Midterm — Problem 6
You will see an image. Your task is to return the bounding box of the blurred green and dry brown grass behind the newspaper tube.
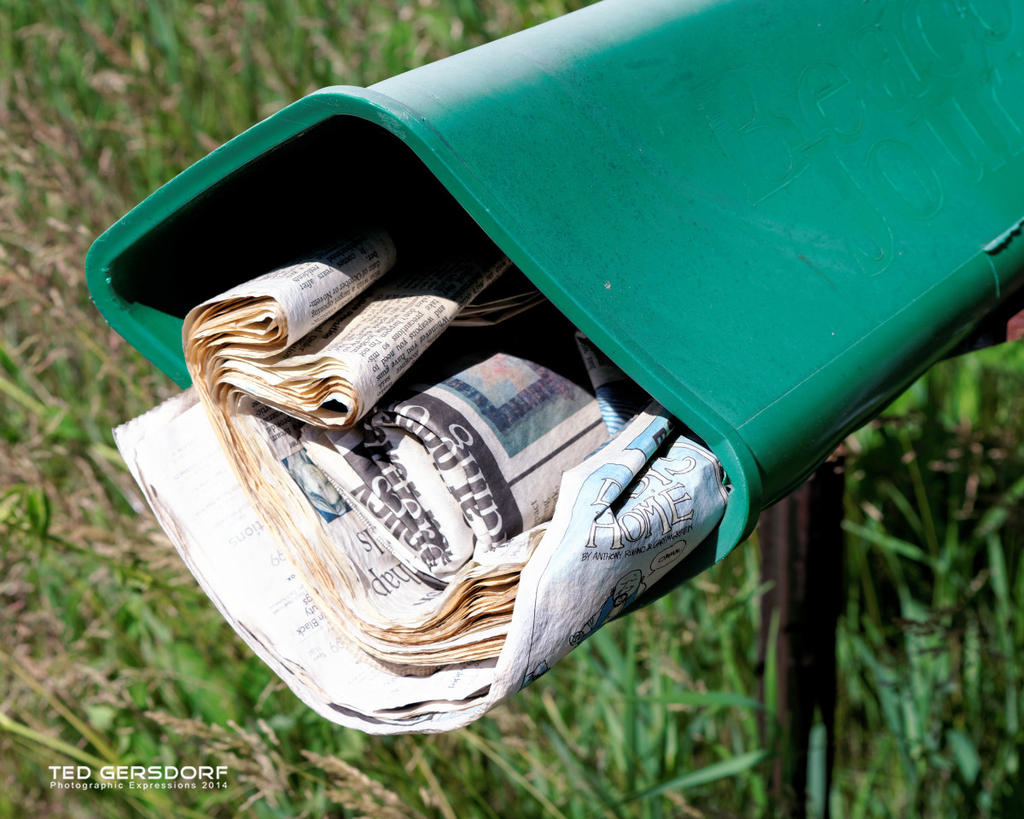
[6,0,1024,817]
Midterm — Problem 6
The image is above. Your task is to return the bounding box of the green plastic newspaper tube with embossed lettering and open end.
[87,0,1024,574]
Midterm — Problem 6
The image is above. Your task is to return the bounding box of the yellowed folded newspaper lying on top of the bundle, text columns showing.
[182,225,510,427]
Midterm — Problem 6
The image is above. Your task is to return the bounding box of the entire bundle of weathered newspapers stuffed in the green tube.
[115,230,727,733]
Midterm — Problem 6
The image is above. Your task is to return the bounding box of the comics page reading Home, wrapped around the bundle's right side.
[490,402,728,702]
